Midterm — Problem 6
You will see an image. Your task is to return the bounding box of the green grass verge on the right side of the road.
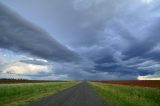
[90,82,160,106]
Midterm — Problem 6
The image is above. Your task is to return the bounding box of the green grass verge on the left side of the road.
[0,82,77,106]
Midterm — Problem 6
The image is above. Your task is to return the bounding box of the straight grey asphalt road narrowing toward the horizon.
[28,82,103,106]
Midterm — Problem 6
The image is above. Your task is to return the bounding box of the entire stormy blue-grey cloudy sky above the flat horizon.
[0,0,160,80]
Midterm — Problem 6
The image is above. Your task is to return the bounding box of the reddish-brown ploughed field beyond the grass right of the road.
[95,80,160,88]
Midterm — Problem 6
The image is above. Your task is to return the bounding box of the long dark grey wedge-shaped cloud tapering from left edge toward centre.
[0,4,79,61]
